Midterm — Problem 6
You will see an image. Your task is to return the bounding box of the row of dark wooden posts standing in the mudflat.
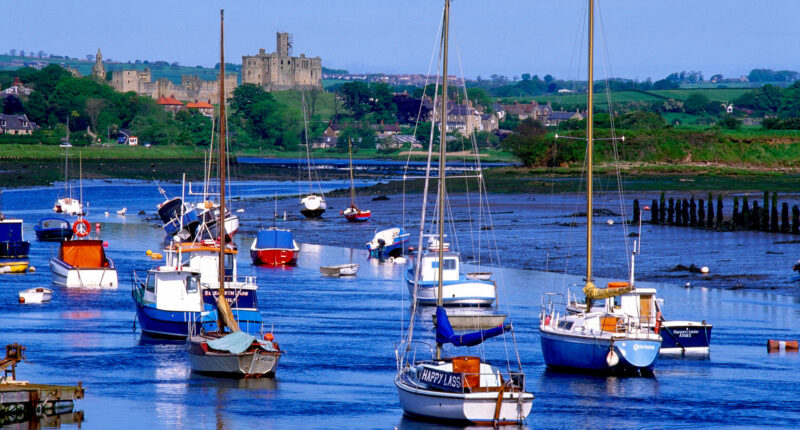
[633,191,800,234]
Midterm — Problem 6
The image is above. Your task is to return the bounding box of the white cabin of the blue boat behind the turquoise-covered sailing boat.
[143,266,203,312]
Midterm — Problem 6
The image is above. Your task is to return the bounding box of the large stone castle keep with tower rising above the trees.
[242,33,322,91]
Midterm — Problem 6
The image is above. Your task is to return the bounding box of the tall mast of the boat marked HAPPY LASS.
[436,0,450,360]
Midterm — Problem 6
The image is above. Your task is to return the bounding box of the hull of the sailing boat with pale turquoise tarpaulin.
[186,336,280,378]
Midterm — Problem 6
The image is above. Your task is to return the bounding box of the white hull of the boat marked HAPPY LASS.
[395,376,533,425]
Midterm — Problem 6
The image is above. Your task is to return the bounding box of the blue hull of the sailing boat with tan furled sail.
[539,329,661,374]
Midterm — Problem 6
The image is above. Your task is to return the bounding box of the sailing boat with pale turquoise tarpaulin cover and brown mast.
[186,10,282,378]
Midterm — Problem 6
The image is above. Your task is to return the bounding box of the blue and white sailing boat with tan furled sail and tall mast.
[539,0,661,374]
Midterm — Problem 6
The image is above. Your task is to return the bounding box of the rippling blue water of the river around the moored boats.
[0,181,800,429]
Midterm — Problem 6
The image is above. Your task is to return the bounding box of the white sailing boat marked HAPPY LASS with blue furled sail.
[394,0,533,425]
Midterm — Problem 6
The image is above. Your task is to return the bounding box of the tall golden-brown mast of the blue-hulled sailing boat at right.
[585,0,594,286]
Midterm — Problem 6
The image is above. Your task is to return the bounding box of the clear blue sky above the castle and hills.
[6,0,800,80]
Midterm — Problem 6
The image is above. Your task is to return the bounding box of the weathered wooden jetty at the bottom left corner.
[0,343,84,425]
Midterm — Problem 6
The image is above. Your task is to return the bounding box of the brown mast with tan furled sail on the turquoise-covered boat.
[217,9,240,334]
